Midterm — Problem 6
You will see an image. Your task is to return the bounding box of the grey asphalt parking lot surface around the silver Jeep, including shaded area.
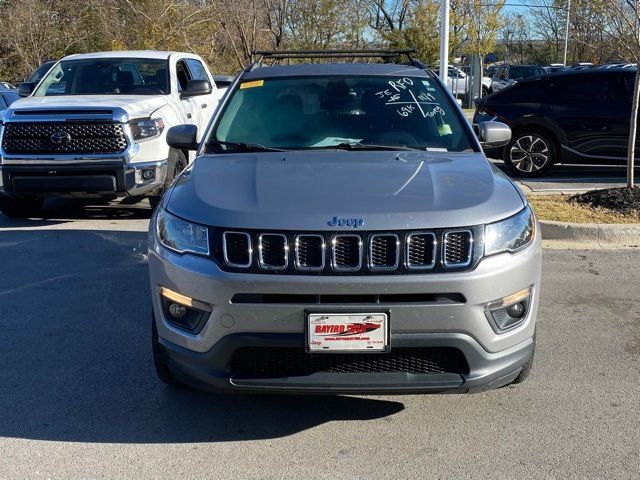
[0,193,640,479]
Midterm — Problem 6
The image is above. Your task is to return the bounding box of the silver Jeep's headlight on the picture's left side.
[156,209,209,256]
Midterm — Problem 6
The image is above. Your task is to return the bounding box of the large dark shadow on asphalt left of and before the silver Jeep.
[0,229,404,443]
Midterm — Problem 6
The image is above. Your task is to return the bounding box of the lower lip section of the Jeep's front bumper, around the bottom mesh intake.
[160,333,534,394]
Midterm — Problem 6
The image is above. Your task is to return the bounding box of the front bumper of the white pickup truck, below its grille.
[0,160,167,197]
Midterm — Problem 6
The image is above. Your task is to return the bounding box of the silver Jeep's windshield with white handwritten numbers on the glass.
[206,75,473,152]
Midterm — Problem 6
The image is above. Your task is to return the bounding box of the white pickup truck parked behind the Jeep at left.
[0,51,220,218]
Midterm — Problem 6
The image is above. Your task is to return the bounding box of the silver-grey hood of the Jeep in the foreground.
[167,150,524,231]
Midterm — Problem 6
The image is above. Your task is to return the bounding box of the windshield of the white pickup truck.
[34,58,169,97]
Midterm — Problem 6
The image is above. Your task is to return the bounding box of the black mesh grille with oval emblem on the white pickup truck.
[2,122,127,155]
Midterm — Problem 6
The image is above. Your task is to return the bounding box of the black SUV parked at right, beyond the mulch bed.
[473,69,635,177]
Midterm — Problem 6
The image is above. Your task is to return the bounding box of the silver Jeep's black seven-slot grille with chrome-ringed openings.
[216,227,482,275]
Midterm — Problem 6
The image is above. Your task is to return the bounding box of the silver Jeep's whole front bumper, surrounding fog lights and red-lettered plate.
[149,229,541,393]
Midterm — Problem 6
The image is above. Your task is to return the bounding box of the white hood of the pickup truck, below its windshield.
[11,95,167,118]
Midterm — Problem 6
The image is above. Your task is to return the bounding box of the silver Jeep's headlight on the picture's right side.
[484,206,536,255]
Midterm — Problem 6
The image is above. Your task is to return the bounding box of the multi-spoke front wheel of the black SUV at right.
[503,129,557,178]
